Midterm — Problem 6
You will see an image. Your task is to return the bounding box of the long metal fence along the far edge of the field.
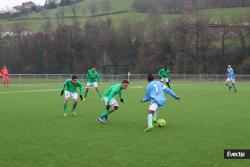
[6,74,250,83]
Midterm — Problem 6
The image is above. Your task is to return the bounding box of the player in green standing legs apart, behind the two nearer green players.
[83,66,102,101]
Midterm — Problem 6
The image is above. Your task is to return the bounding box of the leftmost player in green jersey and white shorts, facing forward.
[61,75,83,117]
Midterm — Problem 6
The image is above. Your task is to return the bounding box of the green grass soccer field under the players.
[0,82,250,167]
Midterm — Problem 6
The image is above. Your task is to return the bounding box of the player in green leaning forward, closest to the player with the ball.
[98,80,129,123]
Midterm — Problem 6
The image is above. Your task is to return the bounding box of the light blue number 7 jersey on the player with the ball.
[142,81,178,106]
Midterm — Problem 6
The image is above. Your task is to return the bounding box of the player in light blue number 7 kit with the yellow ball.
[141,74,180,132]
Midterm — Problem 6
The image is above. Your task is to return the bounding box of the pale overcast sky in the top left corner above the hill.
[0,0,46,10]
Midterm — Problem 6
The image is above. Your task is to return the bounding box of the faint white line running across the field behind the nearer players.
[0,84,193,94]
